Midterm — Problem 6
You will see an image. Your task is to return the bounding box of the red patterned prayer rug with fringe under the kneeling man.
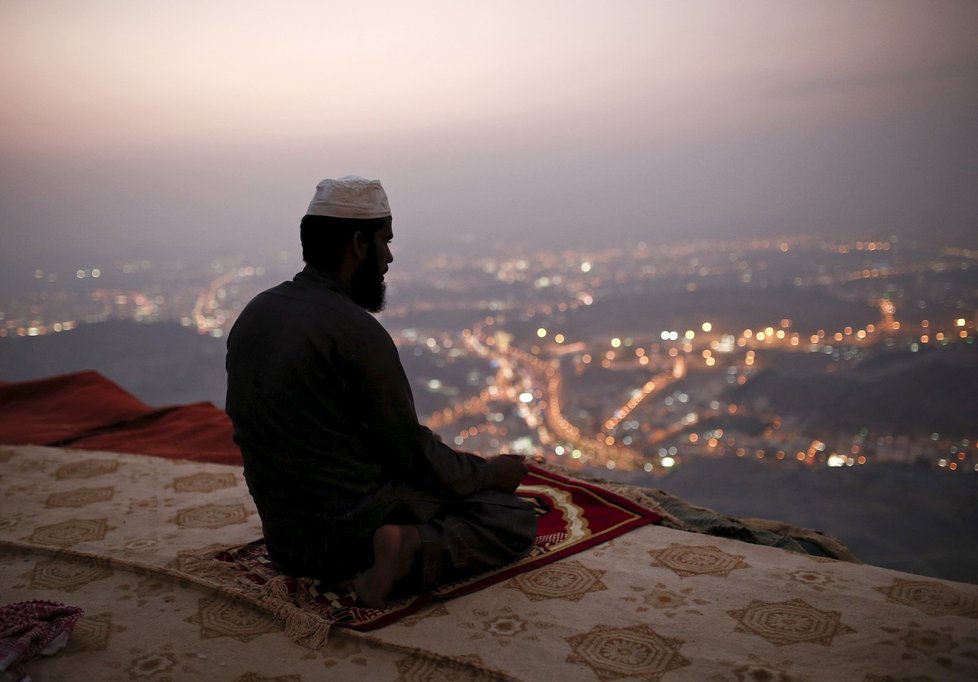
[195,465,661,628]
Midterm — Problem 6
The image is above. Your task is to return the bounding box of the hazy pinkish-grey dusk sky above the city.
[0,0,978,256]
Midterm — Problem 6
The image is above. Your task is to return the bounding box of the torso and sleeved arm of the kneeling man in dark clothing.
[226,267,508,571]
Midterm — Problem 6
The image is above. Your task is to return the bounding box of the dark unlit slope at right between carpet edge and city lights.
[616,457,978,582]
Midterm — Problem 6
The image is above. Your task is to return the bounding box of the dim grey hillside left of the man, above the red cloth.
[0,320,226,406]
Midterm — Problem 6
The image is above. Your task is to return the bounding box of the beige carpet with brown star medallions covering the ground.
[0,446,978,682]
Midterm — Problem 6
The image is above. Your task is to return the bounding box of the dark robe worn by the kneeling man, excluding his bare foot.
[226,266,536,587]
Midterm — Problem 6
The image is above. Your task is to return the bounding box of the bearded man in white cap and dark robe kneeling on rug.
[227,176,536,607]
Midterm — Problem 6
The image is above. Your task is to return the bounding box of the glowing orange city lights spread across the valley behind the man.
[0,241,978,476]
